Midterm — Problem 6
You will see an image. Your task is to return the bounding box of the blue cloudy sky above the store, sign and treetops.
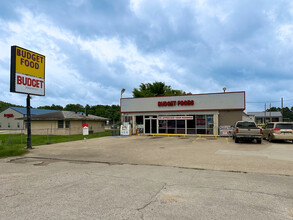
[0,0,293,111]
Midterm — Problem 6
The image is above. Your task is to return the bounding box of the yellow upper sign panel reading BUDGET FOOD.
[15,46,45,79]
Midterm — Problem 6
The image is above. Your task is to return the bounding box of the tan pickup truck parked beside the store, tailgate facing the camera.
[233,121,262,144]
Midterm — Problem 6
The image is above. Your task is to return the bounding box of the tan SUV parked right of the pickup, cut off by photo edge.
[263,122,293,142]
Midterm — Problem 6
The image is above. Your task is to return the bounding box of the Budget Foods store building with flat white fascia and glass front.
[120,91,245,135]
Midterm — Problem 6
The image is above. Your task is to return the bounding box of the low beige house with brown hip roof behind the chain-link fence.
[25,111,108,135]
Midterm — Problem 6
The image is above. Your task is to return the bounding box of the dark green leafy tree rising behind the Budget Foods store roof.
[132,82,191,98]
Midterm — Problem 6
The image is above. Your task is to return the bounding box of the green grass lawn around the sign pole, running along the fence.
[0,130,116,158]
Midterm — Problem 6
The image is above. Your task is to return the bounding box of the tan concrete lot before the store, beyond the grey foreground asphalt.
[25,136,293,176]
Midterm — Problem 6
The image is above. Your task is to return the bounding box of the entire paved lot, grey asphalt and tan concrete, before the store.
[0,136,293,219]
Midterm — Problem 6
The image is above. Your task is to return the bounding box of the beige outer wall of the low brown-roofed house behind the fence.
[25,120,105,135]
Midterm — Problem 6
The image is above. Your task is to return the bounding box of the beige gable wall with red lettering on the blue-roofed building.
[0,108,23,129]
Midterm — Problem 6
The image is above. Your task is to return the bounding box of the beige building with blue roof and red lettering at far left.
[0,107,57,130]
